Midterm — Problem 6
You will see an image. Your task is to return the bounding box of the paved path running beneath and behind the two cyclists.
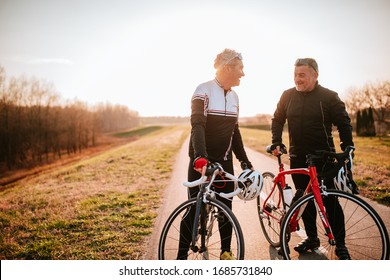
[143,138,390,260]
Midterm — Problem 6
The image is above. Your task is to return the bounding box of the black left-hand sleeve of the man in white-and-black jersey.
[191,99,207,158]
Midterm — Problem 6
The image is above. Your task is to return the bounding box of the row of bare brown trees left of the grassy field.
[0,66,139,170]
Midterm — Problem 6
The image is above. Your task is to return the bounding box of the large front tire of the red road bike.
[280,190,389,260]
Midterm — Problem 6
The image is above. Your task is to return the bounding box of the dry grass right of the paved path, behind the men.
[241,128,390,205]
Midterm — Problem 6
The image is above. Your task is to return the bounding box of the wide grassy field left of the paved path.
[0,127,188,260]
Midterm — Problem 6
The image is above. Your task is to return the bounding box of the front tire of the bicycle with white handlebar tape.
[158,198,245,260]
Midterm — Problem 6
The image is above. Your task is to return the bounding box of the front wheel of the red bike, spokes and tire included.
[280,190,389,260]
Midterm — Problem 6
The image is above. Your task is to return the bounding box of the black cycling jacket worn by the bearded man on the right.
[272,83,353,158]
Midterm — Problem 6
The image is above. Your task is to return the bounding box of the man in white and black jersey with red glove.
[178,49,253,260]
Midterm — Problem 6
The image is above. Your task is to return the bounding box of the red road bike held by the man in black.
[257,147,389,260]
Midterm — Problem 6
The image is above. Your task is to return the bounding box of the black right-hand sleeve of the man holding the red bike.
[331,93,354,151]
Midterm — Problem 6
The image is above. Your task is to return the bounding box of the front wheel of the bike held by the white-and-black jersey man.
[158,198,244,260]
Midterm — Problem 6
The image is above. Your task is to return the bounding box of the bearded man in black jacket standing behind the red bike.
[272,58,353,259]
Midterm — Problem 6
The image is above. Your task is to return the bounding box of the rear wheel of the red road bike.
[257,172,285,247]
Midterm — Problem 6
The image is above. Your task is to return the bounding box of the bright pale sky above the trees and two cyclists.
[0,0,390,117]
